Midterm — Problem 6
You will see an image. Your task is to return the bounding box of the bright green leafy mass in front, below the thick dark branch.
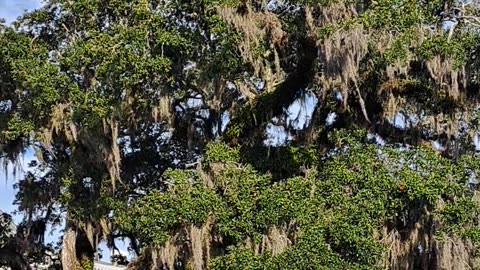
[115,139,480,269]
